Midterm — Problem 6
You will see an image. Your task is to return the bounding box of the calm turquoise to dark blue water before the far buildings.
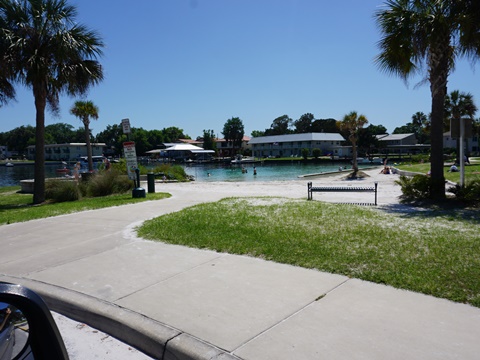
[0,161,368,186]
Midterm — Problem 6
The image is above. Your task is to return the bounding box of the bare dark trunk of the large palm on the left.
[33,85,47,204]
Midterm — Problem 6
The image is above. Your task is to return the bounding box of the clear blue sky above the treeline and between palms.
[0,0,480,138]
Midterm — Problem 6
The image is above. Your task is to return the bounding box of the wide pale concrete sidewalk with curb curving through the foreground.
[0,185,480,360]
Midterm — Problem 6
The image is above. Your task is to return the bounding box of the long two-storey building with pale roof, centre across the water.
[249,133,344,157]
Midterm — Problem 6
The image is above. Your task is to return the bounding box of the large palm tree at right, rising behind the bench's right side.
[375,0,480,199]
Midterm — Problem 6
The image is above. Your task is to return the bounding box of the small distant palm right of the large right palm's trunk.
[445,90,477,163]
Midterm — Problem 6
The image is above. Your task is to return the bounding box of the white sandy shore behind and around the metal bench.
[156,168,401,206]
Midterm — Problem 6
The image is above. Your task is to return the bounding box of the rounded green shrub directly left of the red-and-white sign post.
[86,169,133,197]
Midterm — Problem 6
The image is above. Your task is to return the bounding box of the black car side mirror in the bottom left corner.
[0,282,68,360]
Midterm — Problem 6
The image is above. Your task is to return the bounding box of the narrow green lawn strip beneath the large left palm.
[0,186,171,225]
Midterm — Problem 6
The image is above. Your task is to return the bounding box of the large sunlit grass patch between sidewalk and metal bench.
[138,198,480,307]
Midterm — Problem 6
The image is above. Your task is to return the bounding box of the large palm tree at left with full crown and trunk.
[0,0,103,204]
